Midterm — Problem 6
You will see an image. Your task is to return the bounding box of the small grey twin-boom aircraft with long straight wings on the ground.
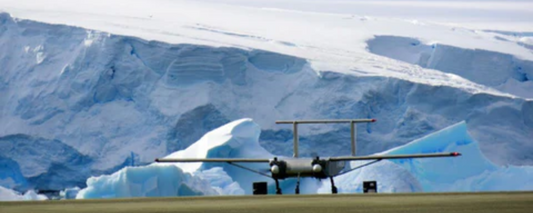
[155,119,461,194]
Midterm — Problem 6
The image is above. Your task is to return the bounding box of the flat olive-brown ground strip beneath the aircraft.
[0,192,533,213]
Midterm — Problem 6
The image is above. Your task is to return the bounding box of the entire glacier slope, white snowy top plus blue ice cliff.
[0,0,533,195]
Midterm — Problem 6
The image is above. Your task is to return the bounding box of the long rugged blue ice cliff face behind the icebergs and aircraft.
[0,13,533,195]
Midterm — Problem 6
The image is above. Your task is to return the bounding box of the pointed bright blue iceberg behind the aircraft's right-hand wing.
[326,122,533,193]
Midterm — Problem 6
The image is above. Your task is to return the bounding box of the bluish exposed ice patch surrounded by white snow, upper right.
[368,36,533,98]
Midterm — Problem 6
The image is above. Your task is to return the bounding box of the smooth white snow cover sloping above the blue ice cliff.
[2,0,533,86]
